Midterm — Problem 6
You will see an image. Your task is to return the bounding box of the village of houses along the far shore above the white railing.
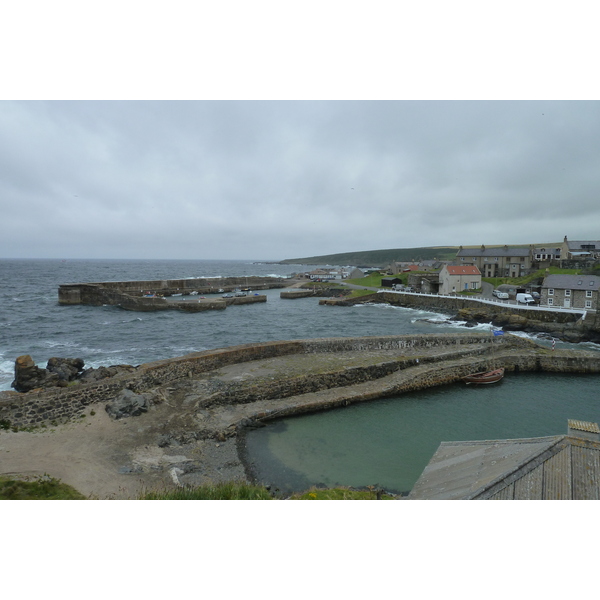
[304,236,600,311]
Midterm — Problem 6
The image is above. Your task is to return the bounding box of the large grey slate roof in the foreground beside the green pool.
[408,426,600,500]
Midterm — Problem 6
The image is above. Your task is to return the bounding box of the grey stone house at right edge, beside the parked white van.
[540,275,600,310]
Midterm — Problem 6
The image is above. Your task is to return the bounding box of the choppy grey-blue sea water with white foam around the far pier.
[0,260,510,390]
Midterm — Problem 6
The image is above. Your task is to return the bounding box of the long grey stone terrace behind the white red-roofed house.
[454,245,532,277]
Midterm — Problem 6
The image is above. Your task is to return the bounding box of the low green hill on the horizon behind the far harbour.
[280,246,458,267]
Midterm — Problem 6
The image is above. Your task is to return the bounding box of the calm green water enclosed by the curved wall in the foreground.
[246,373,600,493]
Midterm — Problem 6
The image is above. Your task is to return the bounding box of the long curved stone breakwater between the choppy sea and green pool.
[0,334,600,435]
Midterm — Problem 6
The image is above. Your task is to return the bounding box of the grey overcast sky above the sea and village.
[0,101,600,260]
